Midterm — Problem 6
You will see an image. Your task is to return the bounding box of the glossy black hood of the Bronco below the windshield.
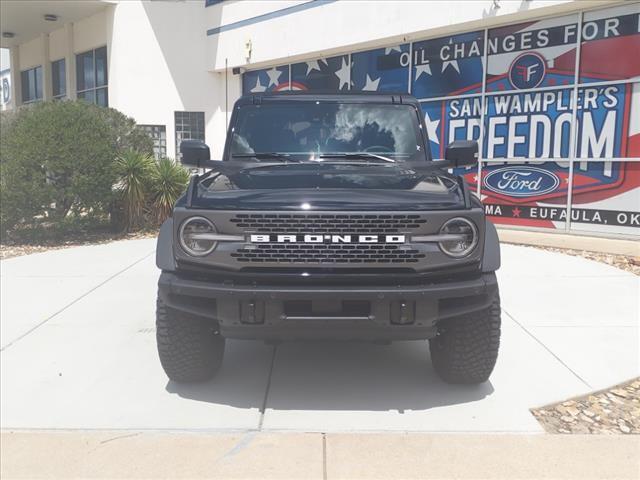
[188,163,464,210]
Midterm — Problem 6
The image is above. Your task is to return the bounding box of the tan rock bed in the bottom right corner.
[531,378,640,435]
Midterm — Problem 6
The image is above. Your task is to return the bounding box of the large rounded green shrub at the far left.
[0,101,152,233]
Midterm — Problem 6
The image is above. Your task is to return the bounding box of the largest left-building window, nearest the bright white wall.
[76,47,109,107]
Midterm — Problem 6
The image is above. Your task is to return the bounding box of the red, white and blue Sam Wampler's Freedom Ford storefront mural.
[243,2,640,235]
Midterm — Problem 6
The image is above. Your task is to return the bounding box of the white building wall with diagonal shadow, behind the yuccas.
[107,1,224,156]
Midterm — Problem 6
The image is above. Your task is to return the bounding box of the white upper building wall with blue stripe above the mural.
[205,0,611,71]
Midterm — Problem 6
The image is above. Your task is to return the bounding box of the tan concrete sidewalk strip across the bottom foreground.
[0,431,640,480]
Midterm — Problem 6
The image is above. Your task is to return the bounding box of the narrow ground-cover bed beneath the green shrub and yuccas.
[0,230,158,260]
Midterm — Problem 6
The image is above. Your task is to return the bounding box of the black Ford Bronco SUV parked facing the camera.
[156,93,500,383]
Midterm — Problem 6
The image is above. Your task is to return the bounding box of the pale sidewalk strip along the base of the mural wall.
[498,228,640,257]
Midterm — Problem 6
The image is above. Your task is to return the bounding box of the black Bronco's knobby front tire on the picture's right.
[429,293,500,384]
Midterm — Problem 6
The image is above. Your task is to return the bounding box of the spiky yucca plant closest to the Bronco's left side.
[149,158,189,224]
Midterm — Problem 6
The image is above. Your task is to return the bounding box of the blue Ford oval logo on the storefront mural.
[482,166,560,197]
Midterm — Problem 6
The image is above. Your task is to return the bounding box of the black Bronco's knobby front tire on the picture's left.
[156,297,225,383]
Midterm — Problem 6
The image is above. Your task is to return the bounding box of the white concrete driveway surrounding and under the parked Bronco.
[0,240,640,432]
